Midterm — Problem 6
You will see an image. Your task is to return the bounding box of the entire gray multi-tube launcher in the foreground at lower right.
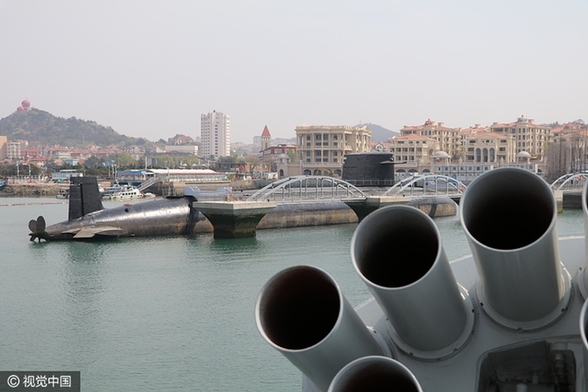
[254,168,588,392]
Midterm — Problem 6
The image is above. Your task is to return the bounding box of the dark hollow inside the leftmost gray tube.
[259,266,342,350]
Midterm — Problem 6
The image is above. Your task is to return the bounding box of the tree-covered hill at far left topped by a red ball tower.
[0,109,148,147]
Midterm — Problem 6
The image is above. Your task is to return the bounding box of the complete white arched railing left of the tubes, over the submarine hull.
[247,176,367,201]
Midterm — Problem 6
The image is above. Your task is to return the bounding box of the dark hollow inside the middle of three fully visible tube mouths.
[354,209,440,288]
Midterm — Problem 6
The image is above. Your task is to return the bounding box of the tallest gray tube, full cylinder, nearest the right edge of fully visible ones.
[460,168,565,323]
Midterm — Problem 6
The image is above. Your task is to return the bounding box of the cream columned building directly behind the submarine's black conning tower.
[296,125,372,176]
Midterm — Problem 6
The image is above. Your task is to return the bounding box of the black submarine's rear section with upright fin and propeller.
[29,177,208,242]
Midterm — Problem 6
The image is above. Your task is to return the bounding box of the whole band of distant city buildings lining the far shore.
[0,99,588,183]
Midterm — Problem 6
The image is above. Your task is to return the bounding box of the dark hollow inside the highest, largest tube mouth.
[463,171,554,250]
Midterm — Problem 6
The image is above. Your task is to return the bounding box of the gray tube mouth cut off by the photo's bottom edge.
[328,356,423,392]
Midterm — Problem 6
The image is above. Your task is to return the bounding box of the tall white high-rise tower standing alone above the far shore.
[199,111,231,159]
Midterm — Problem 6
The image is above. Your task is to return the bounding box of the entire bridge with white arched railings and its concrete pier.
[206,173,588,238]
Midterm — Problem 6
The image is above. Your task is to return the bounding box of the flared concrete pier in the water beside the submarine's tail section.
[194,201,276,238]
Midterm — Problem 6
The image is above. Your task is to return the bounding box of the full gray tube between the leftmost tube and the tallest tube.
[351,206,471,356]
